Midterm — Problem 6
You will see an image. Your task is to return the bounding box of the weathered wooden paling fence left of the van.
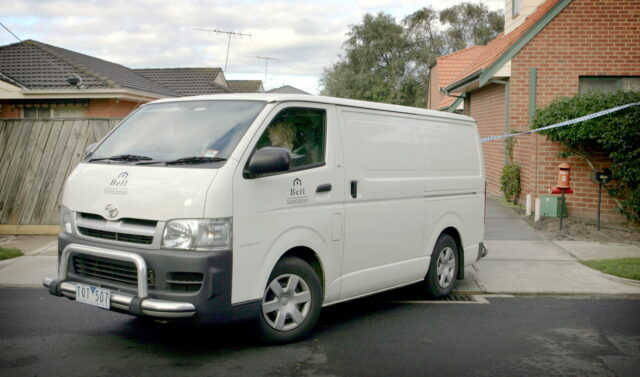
[0,119,120,225]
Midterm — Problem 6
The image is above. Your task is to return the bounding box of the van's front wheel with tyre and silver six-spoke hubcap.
[258,257,323,344]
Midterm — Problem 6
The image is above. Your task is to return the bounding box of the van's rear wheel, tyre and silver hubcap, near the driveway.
[425,234,460,298]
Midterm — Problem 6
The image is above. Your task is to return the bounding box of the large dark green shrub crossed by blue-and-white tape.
[532,91,640,222]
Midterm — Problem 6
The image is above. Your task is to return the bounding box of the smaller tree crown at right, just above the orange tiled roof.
[440,3,504,52]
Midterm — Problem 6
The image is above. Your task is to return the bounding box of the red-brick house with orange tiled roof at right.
[428,0,640,222]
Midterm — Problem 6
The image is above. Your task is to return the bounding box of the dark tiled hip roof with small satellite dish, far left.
[0,40,177,96]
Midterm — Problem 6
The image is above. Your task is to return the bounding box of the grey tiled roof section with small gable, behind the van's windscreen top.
[134,68,232,96]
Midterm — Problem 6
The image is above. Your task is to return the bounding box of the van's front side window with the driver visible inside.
[256,108,326,170]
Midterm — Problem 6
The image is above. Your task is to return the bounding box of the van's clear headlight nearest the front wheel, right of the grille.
[162,217,232,251]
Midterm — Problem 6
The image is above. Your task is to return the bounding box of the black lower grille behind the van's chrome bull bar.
[73,254,155,288]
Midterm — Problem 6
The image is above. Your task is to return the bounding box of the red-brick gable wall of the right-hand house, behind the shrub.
[504,0,640,222]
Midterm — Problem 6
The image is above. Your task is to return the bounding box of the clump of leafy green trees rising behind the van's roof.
[320,3,504,107]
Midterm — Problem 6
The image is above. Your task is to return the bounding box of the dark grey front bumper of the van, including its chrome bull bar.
[43,233,261,323]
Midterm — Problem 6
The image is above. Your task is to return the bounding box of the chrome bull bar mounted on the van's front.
[42,244,196,318]
